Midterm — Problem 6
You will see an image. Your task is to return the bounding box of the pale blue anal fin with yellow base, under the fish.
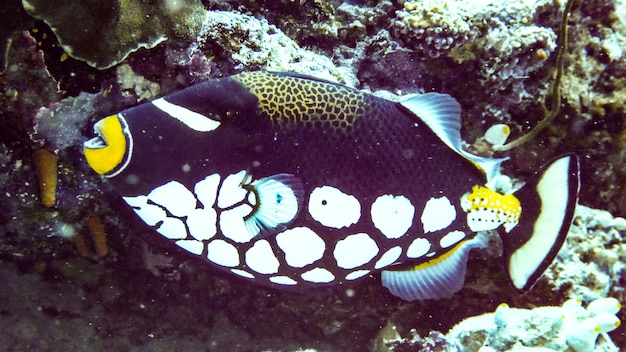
[382,233,488,301]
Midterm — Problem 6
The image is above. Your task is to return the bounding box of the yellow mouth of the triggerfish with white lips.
[83,115,131,176]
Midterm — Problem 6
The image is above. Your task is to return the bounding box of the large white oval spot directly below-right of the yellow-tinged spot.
[333,233,378,269]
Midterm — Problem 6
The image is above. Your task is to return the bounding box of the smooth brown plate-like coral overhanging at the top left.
[22,0,204,68]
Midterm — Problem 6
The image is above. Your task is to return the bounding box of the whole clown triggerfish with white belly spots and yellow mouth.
[84,72,579,300]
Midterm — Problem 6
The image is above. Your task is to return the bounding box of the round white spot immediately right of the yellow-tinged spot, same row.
[372,194,415,238]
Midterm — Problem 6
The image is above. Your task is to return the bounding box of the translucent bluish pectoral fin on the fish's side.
[244,174,304,237]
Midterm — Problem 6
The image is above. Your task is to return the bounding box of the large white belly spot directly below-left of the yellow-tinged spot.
[276,227,326,268]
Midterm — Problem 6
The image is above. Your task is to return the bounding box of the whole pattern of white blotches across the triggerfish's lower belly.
[124,170,458,285]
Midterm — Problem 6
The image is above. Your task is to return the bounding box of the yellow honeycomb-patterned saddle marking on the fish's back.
[233,71,370,131]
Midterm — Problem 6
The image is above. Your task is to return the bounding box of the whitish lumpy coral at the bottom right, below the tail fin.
[446,298,620,352]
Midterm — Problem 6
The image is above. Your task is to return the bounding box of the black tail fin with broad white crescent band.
[502,154,579,291]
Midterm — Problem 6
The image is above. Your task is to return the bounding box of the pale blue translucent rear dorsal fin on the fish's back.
[400,92,508,180]
